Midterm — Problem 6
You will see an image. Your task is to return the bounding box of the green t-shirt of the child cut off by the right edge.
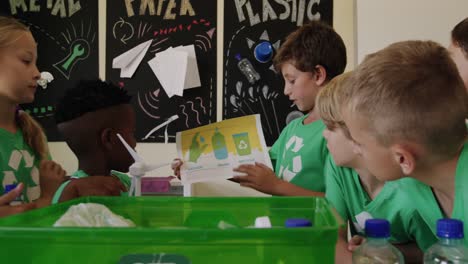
[450,142,468,246]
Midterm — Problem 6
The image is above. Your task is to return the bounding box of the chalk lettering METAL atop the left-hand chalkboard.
[10,0,81,17]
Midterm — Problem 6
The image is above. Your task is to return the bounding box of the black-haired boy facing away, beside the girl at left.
[53,80,136,203]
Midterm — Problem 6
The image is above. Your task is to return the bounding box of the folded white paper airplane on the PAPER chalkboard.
[112,40,153,78]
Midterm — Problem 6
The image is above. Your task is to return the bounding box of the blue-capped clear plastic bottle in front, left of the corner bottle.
[353,219,405,264]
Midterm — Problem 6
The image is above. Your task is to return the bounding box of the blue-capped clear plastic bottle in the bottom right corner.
[424,219,468,264]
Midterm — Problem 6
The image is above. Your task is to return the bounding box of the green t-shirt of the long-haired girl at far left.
[0,128,41,202]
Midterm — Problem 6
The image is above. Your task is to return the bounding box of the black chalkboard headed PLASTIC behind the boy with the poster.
[223,0,333,146]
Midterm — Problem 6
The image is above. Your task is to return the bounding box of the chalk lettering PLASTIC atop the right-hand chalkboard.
[234,0,320,26]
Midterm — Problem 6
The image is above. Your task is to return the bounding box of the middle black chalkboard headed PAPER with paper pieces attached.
[106,0,217,142]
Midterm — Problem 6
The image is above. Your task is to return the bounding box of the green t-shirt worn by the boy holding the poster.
[270,116,328,192]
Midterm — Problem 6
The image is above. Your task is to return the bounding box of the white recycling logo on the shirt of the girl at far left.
[0,149,40,201]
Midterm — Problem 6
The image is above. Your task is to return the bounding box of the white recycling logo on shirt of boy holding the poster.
[279,136,304,182]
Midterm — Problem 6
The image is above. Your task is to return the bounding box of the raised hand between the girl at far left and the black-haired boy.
[37,160,68,207]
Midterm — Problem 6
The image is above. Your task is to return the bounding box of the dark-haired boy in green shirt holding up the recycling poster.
[235,22,346,196]
